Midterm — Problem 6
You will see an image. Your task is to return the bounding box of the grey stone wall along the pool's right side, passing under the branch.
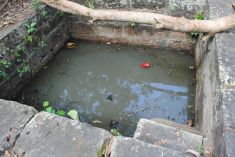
[196,0,235,157]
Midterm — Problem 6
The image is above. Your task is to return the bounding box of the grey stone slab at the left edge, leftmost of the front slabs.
[0,99,37,151]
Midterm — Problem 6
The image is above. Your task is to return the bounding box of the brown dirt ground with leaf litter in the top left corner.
[0,0,34,31]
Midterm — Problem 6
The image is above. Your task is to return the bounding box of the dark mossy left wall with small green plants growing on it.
[0,7,68,98]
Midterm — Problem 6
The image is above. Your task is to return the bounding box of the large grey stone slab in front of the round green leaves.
[13,112,111,157]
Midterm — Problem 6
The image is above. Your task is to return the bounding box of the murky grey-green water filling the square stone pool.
[18,41,195,135]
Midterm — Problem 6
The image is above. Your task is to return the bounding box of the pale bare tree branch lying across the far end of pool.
[40,0,235,34]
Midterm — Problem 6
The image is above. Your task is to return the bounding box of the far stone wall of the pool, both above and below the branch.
[68,0,207,53]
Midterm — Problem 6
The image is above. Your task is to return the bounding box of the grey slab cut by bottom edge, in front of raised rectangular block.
[110,137,191,157]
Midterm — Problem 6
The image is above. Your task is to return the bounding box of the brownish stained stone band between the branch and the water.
[70,22,196,53]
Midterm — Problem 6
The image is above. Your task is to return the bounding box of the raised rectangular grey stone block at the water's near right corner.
[134,119,203,152]
